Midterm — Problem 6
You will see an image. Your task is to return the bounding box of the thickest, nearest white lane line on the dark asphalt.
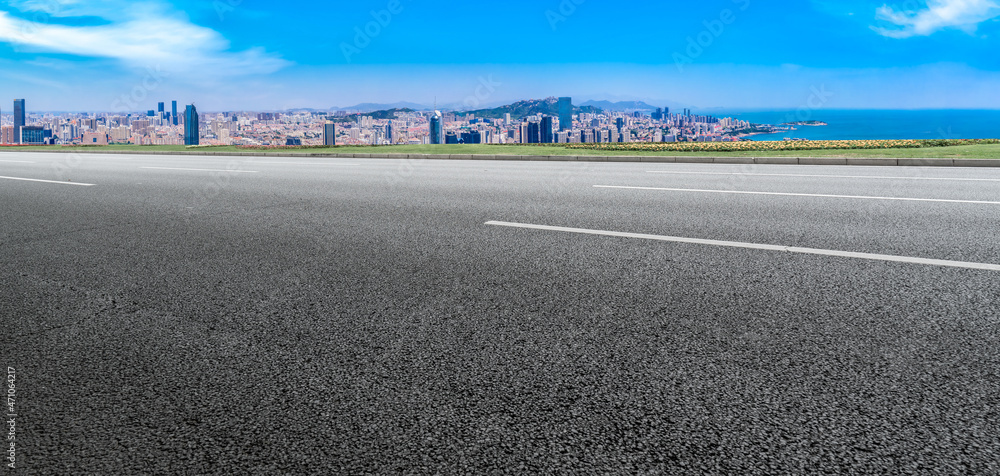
[486,221,1000,271]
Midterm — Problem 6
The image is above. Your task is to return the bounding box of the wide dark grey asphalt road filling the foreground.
[0,152,1000,474]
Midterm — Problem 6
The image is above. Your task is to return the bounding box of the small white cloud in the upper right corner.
[872,0,1000,38]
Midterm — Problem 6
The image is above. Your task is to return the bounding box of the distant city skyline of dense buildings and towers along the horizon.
[0,97,756,146]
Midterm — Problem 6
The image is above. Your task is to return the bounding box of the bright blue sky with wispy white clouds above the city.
[0,0,1000,111]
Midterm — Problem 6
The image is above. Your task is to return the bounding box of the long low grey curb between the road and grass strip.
[0,149,1000,168]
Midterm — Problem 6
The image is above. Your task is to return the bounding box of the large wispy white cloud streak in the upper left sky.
[0,0,290,77]
